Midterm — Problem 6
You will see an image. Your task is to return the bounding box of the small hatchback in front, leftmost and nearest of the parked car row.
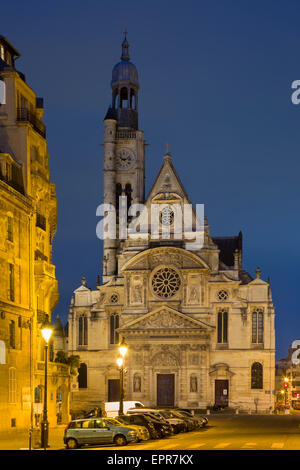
[64,418,138,449]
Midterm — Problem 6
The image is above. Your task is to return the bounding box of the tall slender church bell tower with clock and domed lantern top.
[103,32,145,282]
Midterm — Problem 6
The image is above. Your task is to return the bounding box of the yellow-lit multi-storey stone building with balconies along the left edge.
[0,36,69,431]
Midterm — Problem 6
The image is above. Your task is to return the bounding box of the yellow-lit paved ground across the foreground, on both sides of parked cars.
[0,415,300,452]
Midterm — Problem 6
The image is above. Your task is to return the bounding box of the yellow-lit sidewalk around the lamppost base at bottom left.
[0,424,66,451]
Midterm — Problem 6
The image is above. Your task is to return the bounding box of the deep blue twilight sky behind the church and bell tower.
[0,0,300,358]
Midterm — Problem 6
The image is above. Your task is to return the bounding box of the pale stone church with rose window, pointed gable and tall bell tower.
[62,36,275,411]
